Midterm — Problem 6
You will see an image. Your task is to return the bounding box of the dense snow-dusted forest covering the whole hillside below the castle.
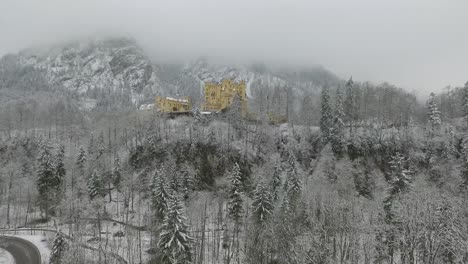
[0,60,468,264]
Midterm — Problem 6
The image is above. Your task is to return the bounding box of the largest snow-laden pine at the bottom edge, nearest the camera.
[158,195,193,264]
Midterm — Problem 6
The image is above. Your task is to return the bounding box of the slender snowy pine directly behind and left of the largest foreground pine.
[151,168,169,220]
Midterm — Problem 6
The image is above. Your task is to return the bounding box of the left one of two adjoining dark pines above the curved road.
[37,141,56,218]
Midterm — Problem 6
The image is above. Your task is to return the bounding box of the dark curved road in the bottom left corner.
[0,236,41,264]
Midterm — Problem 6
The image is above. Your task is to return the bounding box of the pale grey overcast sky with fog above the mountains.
[0,0,468,95]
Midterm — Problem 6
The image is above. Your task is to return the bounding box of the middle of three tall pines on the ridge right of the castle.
[331,87,346,157]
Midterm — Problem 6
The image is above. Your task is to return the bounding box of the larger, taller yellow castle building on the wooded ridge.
[203,79,247,114]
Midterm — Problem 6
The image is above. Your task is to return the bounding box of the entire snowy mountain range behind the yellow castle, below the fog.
[0,35,338,110]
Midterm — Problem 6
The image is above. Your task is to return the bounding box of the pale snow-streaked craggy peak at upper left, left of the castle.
[18,38,161,104]
